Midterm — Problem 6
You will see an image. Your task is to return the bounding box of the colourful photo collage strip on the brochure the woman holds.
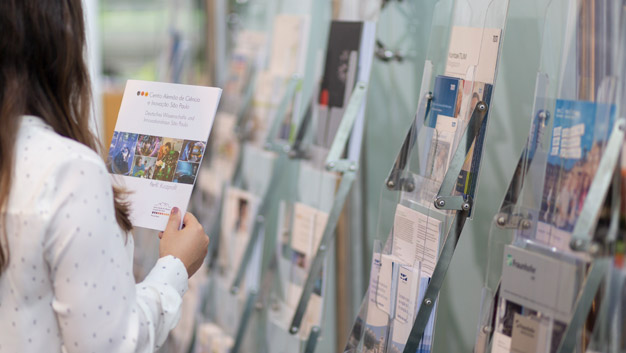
[107,131,206,184]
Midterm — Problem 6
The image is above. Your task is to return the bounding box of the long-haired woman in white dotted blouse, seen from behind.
[0,0,208,353]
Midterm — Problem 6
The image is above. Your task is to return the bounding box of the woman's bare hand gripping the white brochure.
[159,207,209,277]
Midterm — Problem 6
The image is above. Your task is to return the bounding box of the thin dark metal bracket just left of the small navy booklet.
[386,92,433,192]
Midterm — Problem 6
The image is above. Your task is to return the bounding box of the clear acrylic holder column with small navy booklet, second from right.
[344,1,508,353]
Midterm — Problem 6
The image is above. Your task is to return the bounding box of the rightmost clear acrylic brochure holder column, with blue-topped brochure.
[474,0,626,353]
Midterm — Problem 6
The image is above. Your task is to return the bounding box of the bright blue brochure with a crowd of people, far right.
[537,100,615,251]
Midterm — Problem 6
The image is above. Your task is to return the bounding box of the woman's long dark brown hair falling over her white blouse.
[0,0,132,271]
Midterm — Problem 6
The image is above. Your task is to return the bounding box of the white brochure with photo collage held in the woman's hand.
[107,80,222,230]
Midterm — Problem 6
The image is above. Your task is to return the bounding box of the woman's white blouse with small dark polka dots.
[0,116,187,353]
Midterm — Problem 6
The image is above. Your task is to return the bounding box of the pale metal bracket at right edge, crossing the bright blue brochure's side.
[570,118,626,251]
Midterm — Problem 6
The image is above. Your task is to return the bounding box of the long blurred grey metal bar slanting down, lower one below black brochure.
[289,170,356,334]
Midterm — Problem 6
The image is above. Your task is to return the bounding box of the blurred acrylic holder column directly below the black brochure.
[258,24,375,353]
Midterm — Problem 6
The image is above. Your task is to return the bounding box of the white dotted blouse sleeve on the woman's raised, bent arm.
[43,155,187,353]
